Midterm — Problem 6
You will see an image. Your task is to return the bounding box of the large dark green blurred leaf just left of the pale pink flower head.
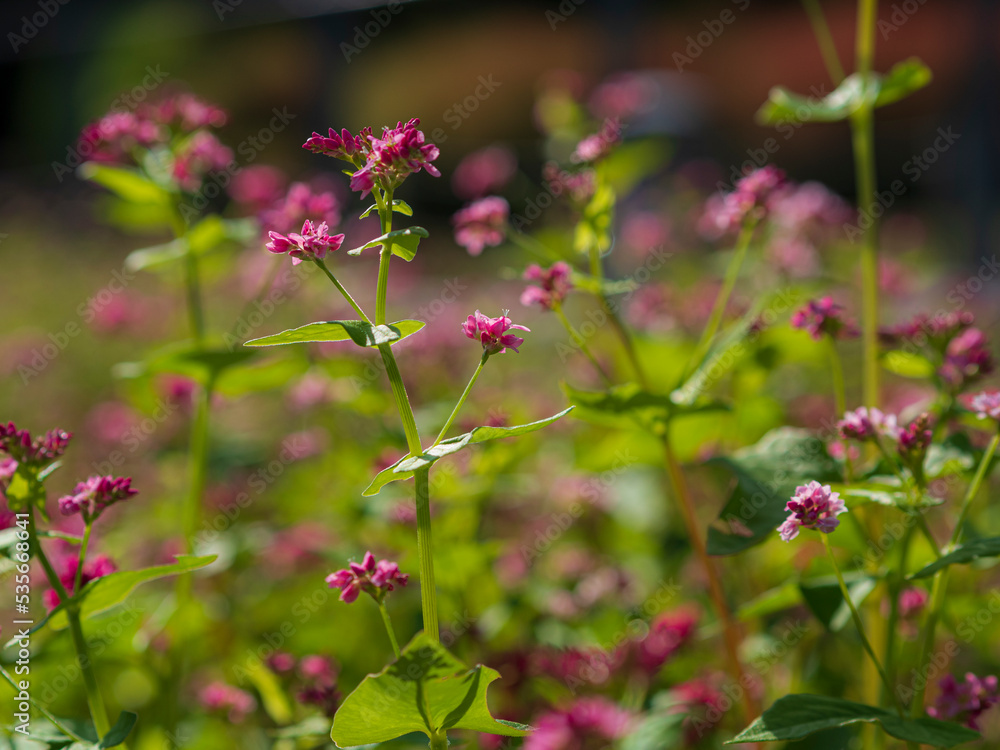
[708,427,840,555]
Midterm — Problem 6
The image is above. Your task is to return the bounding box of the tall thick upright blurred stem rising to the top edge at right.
[850,0,879,407]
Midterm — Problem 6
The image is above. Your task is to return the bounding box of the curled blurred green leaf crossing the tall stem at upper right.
[757,58,932,125]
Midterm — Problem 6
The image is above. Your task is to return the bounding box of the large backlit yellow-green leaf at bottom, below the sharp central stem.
[330,633,531,747]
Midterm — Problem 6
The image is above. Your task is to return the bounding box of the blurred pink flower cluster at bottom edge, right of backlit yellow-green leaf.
[523,696,635,750]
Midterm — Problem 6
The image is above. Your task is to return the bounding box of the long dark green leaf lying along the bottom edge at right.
[726,694,980,747]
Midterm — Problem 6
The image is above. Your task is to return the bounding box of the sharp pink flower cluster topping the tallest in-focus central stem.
[302,118,441,197]
